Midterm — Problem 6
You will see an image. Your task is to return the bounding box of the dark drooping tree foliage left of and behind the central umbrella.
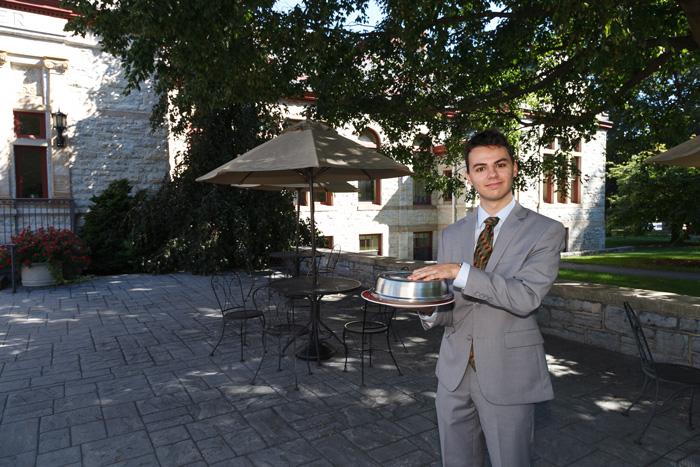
[132,106,308,273]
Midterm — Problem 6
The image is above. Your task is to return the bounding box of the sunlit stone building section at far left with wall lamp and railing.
[0,0,169,243]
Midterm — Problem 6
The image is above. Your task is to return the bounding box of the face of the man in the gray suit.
[467,146,518,205]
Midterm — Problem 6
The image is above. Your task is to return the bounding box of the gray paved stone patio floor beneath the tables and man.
[0,274,700,467]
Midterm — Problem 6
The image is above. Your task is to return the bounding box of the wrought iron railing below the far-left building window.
[0,198,76,244]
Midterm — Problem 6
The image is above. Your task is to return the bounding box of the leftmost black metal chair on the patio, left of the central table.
[209,272,265,368]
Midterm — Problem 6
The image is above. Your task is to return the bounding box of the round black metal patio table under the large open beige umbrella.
[270,276,362,363]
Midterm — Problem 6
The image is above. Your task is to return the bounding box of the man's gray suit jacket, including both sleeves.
[436,203,565,405]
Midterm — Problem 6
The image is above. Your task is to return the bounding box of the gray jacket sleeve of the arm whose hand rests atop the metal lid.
[462,222,565,316]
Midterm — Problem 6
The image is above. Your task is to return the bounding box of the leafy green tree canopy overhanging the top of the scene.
[65,0,700,197]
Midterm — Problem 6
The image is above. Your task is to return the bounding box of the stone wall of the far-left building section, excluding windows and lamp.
[0,8,170,212]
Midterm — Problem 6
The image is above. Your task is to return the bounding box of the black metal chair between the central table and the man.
[343,302,403,386]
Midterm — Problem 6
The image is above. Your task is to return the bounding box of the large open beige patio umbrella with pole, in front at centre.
[197,120,411,286]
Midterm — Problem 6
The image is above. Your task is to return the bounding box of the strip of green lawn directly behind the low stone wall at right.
[559,269,700,297]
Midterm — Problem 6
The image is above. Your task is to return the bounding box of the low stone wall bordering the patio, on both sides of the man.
[322,250,700,368]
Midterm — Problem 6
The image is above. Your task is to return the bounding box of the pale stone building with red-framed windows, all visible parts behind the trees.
[0,0,610,260]
